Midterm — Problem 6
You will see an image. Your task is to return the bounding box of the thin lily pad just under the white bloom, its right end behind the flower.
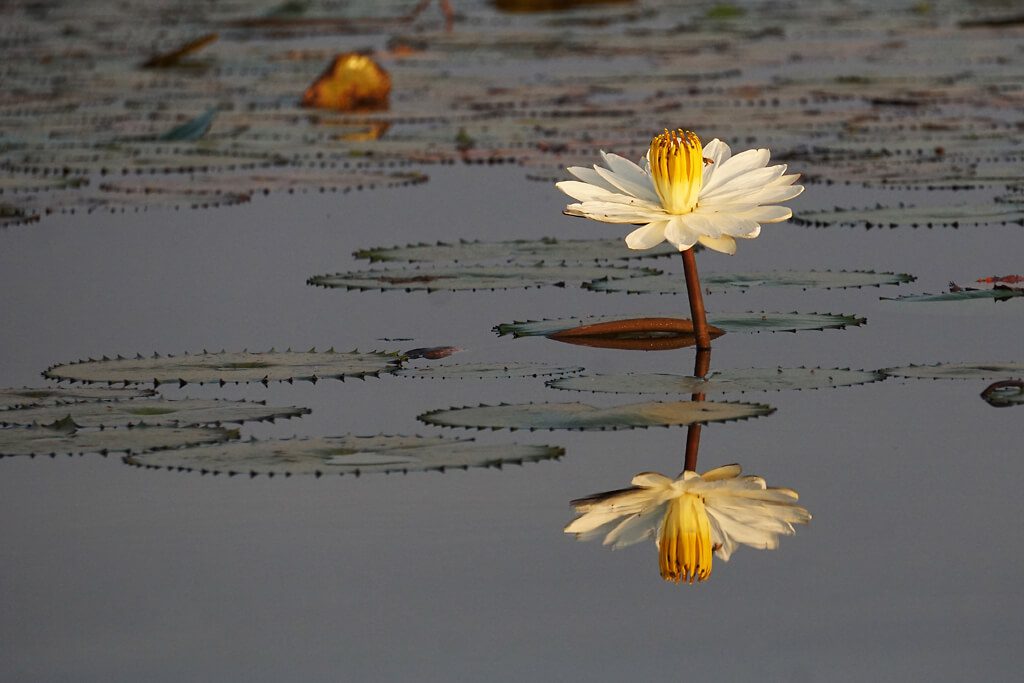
[353,238,677,263]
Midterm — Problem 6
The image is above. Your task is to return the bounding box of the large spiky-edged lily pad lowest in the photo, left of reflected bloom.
[125,434,565,476]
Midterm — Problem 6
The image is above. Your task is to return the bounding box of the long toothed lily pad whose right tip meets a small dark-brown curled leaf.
[43,349,399,385]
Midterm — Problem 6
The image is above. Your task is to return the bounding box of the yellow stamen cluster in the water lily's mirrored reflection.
[658,494,714,584]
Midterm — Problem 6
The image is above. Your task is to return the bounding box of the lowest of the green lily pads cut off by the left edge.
[0,425,239,457]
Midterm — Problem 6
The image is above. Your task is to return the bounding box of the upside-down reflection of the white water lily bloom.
[565,465,811,584]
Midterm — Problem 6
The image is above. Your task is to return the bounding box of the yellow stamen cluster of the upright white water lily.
[648,128,705,214]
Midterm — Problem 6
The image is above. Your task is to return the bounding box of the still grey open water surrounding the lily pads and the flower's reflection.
[0,3,1024,682]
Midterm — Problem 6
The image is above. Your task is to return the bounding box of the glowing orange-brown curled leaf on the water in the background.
[302,52,391,112]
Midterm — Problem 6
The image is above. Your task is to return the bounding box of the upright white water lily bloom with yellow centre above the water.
[556,129,804,254]
